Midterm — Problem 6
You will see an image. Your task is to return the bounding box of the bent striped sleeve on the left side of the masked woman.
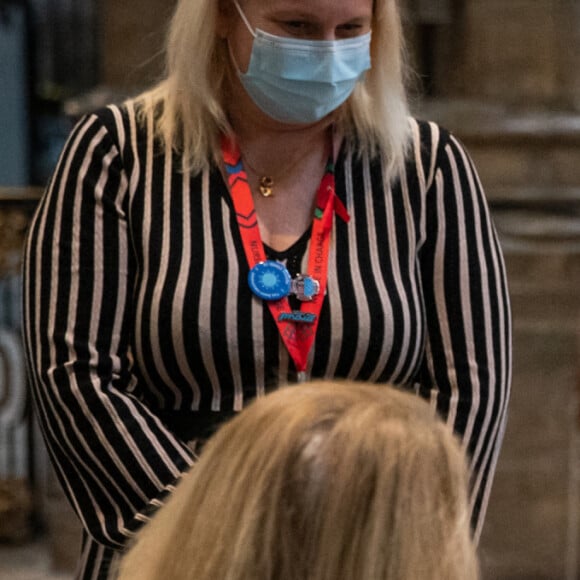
[23,115,192,548]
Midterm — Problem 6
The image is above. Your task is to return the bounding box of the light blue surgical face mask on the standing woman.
[232,0,371,123]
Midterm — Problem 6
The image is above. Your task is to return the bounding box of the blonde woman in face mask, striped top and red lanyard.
[24,0,511,578]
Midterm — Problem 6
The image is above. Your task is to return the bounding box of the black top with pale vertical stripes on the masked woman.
[24,103,511,577]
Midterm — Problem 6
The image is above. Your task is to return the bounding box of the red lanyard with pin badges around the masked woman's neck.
[222,137,350,375]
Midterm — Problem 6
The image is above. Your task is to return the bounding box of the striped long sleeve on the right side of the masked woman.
[420,124,511,538]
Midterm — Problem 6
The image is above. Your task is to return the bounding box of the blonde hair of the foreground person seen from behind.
[119,382,478,580]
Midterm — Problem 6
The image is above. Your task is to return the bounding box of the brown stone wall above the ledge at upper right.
[403,0,580,108]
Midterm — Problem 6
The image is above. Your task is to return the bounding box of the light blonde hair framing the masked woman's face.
[138,0,410,176]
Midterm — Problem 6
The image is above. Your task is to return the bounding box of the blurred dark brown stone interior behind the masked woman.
[0,0,580,580]
